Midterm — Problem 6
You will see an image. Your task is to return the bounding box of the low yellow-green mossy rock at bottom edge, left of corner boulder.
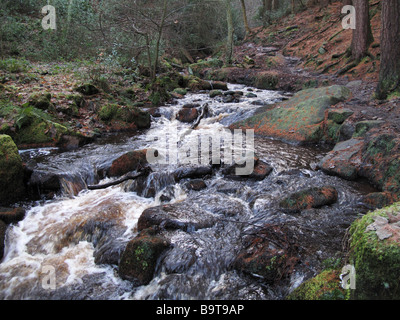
[286,270,348,301]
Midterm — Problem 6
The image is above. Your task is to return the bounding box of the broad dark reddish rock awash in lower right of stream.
[233,226,298,284]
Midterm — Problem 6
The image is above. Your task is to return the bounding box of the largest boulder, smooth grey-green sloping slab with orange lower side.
[231,85,350,143]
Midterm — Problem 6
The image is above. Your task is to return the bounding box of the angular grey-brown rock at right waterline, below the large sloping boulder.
[319,139,364,180]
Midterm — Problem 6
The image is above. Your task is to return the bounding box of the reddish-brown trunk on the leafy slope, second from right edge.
[351,0,374,60]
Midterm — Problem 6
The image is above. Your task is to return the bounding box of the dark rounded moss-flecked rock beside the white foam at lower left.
[118,231,170,285]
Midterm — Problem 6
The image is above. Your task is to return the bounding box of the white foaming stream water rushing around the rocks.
[0,85,368,299]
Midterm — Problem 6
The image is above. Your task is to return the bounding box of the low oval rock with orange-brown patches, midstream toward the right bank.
[279,186,338,212]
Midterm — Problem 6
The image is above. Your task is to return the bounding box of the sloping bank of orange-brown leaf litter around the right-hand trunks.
[231,2,400,133]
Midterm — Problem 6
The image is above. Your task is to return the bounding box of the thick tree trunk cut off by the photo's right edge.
[377,0,400,99]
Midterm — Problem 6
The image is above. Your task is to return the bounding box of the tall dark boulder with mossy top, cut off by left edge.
[0,135,25,205]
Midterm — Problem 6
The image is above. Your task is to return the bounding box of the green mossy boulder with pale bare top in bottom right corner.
[349,203,400,300]
